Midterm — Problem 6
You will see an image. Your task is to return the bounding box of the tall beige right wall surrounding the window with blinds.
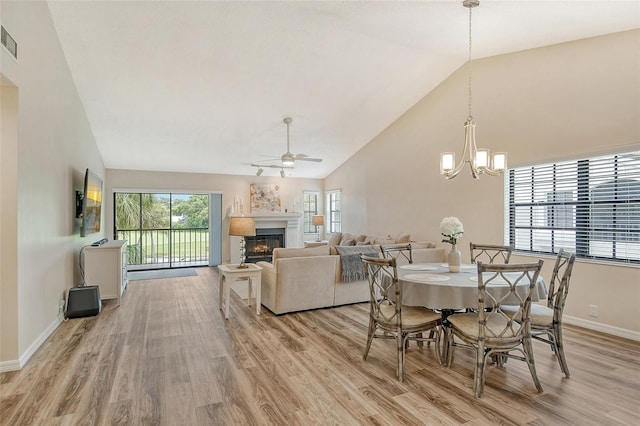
[325,30,640,338]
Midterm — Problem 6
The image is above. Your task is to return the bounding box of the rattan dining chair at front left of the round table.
[360,255,442,382]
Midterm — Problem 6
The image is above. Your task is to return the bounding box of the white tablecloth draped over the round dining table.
[398,263,547,309]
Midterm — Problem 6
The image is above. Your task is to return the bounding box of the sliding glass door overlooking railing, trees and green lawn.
[115,193,209,267]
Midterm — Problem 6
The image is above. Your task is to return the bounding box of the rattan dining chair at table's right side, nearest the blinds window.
[504,249,576,377]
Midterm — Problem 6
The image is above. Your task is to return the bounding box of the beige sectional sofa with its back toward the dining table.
[258,238,445,315]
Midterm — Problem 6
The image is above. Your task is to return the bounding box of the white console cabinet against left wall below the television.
[84,240,127,305]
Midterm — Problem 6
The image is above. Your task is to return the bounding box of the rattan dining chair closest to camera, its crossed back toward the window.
[446,260,543,398]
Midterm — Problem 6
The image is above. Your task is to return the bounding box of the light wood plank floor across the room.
[0,268,640,425]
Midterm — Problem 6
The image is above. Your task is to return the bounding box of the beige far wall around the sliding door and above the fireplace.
[103,169,323,263]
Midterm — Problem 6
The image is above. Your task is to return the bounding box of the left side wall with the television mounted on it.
[0,1,104,370]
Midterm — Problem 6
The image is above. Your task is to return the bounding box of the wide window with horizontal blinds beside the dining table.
[505,152,640,264]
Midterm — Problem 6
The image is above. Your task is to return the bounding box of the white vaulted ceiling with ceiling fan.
[48,0,640,178]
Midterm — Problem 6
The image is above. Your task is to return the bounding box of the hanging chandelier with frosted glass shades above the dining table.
[440,0,507,179]
